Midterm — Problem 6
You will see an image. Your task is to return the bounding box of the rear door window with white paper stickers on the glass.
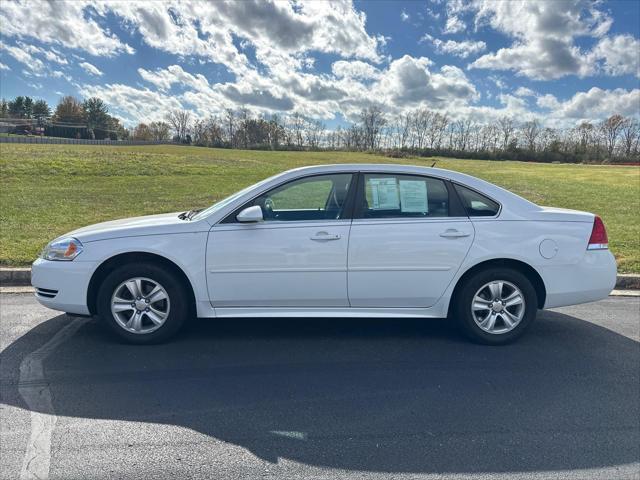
[362,173,449,218]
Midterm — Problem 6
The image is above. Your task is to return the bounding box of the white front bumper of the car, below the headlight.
[31,258,96,315]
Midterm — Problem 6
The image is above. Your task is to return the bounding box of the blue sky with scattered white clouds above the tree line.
[0,0,640,128]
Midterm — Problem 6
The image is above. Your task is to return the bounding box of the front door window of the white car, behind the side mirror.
[245,173,353,222]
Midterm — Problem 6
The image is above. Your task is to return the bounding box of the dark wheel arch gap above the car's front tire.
[87,252,196,315]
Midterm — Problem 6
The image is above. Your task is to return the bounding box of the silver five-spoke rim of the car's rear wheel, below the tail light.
[471,280,525,335]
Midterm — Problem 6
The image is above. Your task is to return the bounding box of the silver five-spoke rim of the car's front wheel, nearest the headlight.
[111,277,171,334]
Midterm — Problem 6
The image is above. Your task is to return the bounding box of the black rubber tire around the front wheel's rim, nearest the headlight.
[96,263,191,345]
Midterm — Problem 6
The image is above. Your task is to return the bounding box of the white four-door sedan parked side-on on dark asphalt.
[32,164,616,344]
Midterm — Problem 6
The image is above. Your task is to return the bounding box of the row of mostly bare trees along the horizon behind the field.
[0,96,640,163]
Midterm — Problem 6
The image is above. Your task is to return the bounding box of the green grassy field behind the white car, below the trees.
[0,144,640,272]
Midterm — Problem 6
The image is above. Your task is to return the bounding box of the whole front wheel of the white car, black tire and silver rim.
[97,263,189,344]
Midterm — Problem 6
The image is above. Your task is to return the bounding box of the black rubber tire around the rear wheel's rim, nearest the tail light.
[451,268,538,345]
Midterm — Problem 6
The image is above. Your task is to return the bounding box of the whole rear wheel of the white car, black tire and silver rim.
[453,268,538,345]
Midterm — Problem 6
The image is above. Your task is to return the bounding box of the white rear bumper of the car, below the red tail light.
[540,250,617,308]
